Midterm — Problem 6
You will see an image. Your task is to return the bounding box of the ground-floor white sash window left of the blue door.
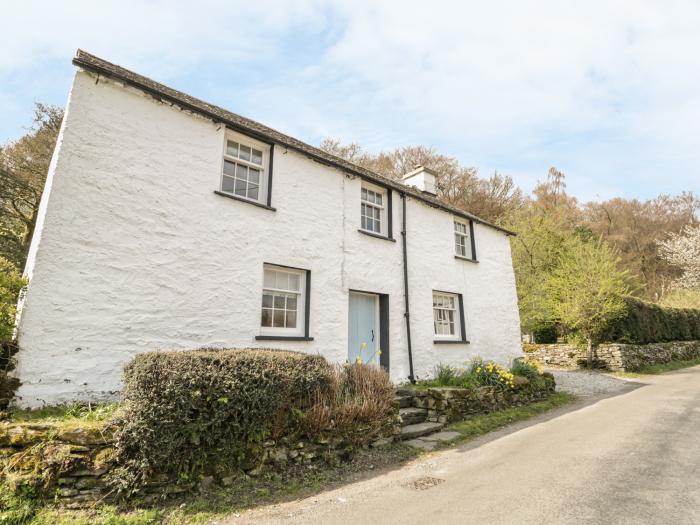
[259,264,310,339]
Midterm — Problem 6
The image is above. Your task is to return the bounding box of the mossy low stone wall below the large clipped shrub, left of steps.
[0,412,401,508]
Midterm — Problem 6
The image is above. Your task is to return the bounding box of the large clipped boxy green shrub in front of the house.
[114,350,336,490]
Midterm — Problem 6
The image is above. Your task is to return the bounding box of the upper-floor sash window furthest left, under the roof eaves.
[221,132,270,202]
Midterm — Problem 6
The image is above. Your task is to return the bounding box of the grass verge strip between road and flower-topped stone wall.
[446,392,576,443]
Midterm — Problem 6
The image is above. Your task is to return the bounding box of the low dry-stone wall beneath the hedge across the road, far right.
[523,341,700,372]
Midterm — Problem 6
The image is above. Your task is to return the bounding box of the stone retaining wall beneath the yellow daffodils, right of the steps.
[399,372,555,423]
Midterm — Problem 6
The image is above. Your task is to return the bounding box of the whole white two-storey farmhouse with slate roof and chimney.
[15,51,521,407]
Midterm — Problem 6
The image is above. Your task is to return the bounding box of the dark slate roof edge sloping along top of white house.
[73,49,515,235]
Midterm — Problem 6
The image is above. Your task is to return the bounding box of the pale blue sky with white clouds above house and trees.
[0,0,700,201]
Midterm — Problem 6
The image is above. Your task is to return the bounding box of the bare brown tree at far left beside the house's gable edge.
[0,104,63,268]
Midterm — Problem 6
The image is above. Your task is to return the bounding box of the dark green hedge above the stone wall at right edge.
[602,297,700,344]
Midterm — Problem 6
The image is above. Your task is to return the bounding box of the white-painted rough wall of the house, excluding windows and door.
[15,71,520,406]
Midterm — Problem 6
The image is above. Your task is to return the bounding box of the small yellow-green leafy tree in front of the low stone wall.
[545,236,629,367]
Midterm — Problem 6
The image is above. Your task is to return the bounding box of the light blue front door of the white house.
[348,292,380,365]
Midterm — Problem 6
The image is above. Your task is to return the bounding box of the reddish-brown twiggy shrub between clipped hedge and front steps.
[302,363,395,444]
